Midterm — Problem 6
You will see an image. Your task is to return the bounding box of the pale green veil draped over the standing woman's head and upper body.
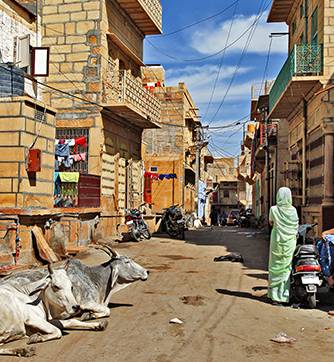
[271,187,298,240]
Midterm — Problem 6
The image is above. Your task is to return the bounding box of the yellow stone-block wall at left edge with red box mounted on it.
[0,97,55,209]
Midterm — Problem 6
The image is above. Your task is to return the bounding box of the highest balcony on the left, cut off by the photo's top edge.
[117,0,162,35]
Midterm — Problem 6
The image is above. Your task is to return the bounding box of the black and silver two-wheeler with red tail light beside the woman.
[290,223,324,308]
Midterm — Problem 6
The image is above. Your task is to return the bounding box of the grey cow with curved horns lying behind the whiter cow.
[0,245,149,321]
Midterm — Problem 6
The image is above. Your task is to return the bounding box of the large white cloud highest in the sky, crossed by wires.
[191,12,288,54]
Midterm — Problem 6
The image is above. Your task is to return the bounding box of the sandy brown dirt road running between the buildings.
[0,227,334,362]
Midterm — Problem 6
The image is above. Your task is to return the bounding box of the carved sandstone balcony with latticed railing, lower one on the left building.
[102,69,161,129]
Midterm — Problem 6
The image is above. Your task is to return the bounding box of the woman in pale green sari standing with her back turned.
[267,187,298,306]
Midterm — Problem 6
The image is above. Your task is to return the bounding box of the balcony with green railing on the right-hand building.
[269,44,323,119]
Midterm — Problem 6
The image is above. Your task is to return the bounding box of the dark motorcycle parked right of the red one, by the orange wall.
[162,204,188,240]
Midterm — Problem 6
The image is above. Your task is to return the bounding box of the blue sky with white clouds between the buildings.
[144,0,288,161]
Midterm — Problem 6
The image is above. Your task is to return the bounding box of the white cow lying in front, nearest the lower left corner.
[0,264,107,356]
